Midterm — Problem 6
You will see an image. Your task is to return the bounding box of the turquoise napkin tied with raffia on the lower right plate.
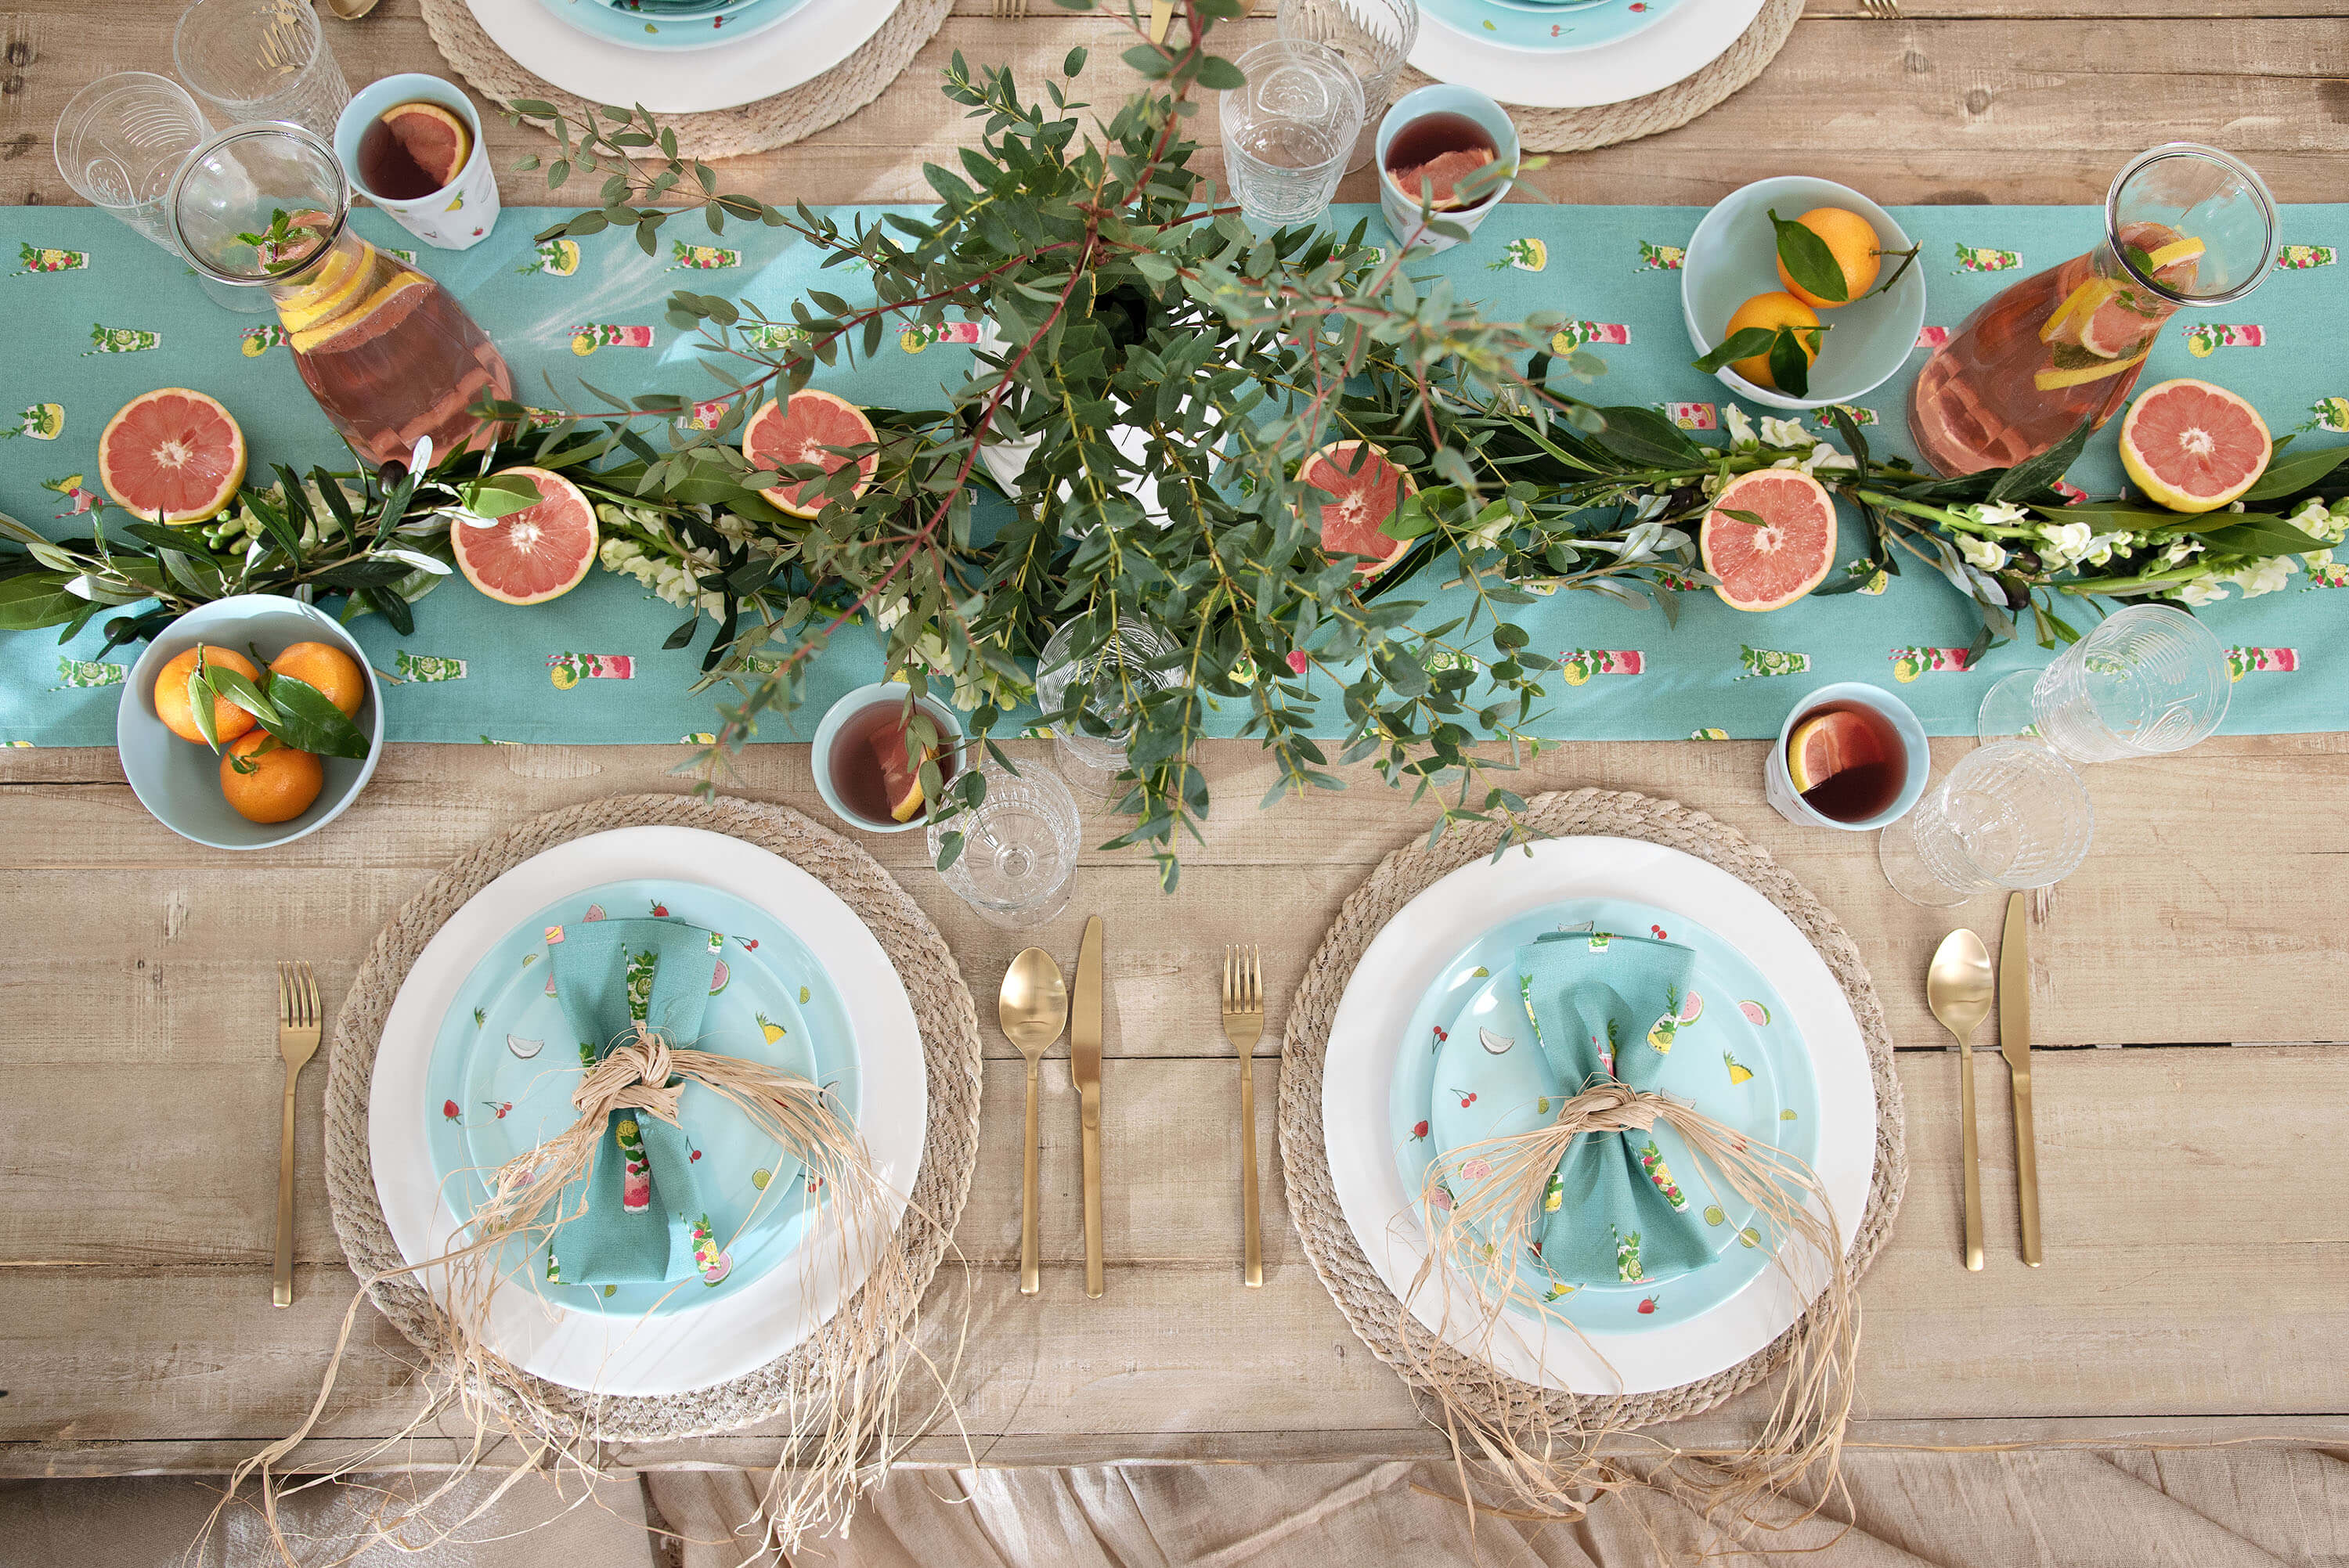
[1431,932,1715,1284]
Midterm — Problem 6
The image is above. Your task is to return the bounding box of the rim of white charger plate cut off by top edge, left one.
[465,0,902,115]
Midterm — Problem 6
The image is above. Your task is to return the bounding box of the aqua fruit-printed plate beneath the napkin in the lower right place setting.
[1388,899,1818,1333]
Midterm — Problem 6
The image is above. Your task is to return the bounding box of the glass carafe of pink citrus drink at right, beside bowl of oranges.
[1910,141,2276,474]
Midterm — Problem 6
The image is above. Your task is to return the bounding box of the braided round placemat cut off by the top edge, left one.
[423,0,954,157]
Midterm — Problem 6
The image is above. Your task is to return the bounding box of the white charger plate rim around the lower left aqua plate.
[366,828,930,1397]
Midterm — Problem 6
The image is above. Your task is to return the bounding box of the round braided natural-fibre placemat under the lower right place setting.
[1280,788,1907,1432]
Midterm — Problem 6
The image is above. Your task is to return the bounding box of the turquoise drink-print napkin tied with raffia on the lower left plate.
[547,920,719,1284]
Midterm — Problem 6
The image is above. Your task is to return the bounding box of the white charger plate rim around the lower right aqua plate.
[1322,838,1877,1394]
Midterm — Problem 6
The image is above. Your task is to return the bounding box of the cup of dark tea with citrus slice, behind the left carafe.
[334,73,498,251]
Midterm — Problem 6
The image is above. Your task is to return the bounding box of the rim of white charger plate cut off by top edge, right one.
[1409,0,1762,108]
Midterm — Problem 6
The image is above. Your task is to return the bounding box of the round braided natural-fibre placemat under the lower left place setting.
[327,795,980,1441]
